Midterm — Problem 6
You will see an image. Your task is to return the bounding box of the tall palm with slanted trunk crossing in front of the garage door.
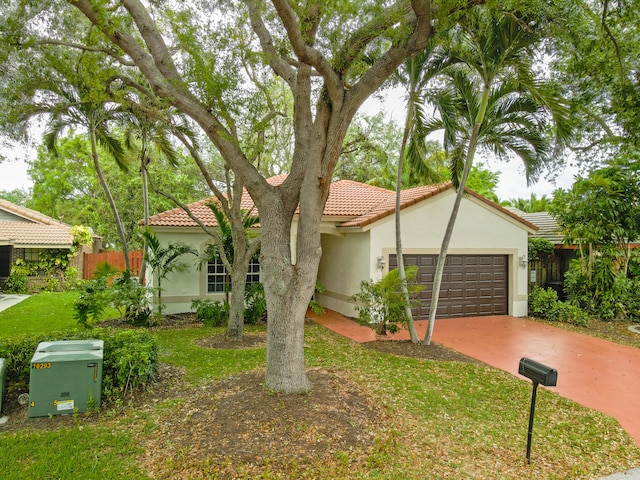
[424,9,571,345]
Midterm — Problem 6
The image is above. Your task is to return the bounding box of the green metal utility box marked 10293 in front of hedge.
[29,340,104,417]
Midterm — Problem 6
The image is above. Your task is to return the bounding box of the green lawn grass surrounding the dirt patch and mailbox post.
[0,294,640,479]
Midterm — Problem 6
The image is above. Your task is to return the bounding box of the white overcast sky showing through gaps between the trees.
[0,90,580,200]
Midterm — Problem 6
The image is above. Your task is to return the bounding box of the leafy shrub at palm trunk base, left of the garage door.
[351,265,424,335]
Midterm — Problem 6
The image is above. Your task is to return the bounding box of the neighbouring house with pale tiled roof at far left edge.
[0,199,95,287]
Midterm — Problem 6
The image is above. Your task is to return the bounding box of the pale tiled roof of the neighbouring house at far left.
[0,199,73,248]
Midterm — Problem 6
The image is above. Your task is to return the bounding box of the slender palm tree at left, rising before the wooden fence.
[22,85,130,270]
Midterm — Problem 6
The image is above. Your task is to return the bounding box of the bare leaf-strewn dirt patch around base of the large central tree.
[138,369,384,478]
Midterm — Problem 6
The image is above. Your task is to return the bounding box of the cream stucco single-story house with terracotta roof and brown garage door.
[147,176,536,318]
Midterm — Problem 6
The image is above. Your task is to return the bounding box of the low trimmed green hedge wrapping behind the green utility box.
[0,328,158,401]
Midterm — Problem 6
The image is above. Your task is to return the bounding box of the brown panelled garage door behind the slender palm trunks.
[389,255,509,319]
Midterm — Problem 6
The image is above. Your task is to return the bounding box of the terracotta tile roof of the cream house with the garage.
[149,175,537,230]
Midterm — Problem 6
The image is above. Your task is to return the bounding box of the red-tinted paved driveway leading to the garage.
[311,311,640,446]
